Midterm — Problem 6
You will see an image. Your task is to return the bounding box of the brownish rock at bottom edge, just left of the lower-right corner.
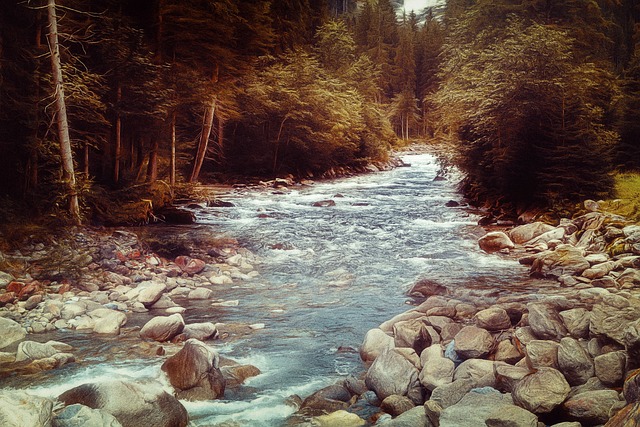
[562,390,620,425]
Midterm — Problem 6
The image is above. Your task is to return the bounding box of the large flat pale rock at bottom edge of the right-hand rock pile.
[440,387,513,427]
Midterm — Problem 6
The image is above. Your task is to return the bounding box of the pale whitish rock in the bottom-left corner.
[0,390,53,427]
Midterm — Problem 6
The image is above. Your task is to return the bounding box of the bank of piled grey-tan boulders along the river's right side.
[300,201,640,427]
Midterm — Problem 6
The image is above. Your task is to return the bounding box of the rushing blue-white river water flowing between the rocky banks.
[5,154,526,426]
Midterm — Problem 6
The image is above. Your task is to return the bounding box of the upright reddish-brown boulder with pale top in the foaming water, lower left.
[162,339,225,400]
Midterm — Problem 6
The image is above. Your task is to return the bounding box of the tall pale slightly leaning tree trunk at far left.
[47,0,81,225]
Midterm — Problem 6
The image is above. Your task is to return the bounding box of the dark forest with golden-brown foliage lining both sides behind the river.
[0,0,640,223]
